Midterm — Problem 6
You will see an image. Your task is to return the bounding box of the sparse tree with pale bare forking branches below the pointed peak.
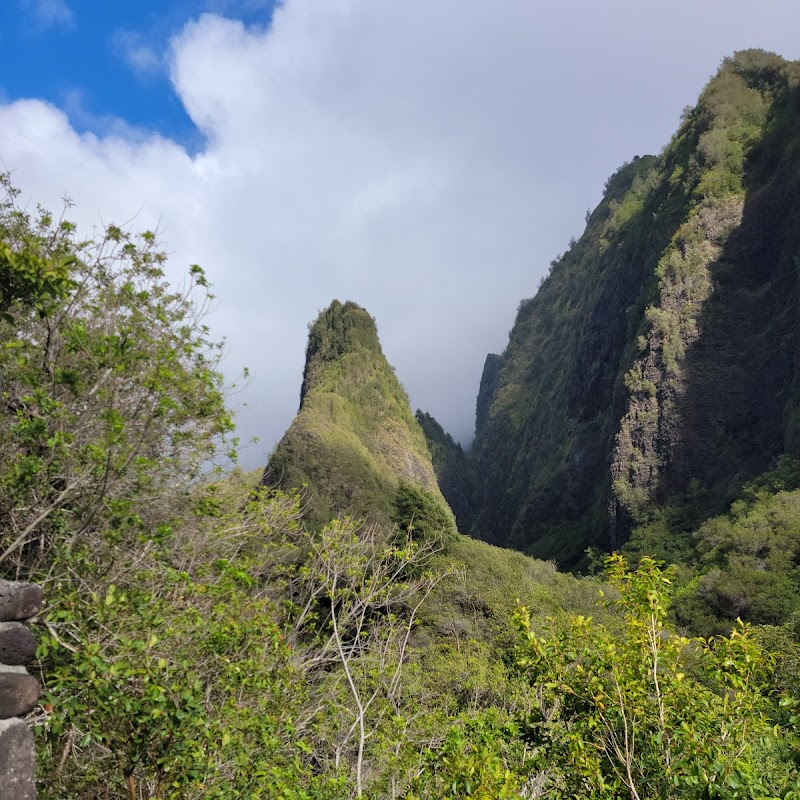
[247,500,451,797]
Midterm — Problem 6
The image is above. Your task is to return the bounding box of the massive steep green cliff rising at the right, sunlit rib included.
[474,51,800,566]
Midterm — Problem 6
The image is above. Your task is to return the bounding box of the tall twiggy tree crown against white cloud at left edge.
[0,177,233,573]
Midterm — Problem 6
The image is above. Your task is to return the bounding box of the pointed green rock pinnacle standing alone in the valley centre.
[264,300,452,526]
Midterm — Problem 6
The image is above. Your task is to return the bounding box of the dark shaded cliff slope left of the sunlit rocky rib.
[474,153,668,563]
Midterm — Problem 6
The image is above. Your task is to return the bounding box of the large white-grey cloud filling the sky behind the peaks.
[0,0,800,463]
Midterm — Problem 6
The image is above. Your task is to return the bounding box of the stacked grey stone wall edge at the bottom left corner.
[0,580,42,800]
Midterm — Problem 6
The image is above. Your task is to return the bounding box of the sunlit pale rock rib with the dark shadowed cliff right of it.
[612,65,800,533]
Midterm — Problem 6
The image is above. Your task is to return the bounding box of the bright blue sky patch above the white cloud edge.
[0,0,274,146]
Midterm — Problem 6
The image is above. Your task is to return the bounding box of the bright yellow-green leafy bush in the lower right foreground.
[518,556,796,800]
